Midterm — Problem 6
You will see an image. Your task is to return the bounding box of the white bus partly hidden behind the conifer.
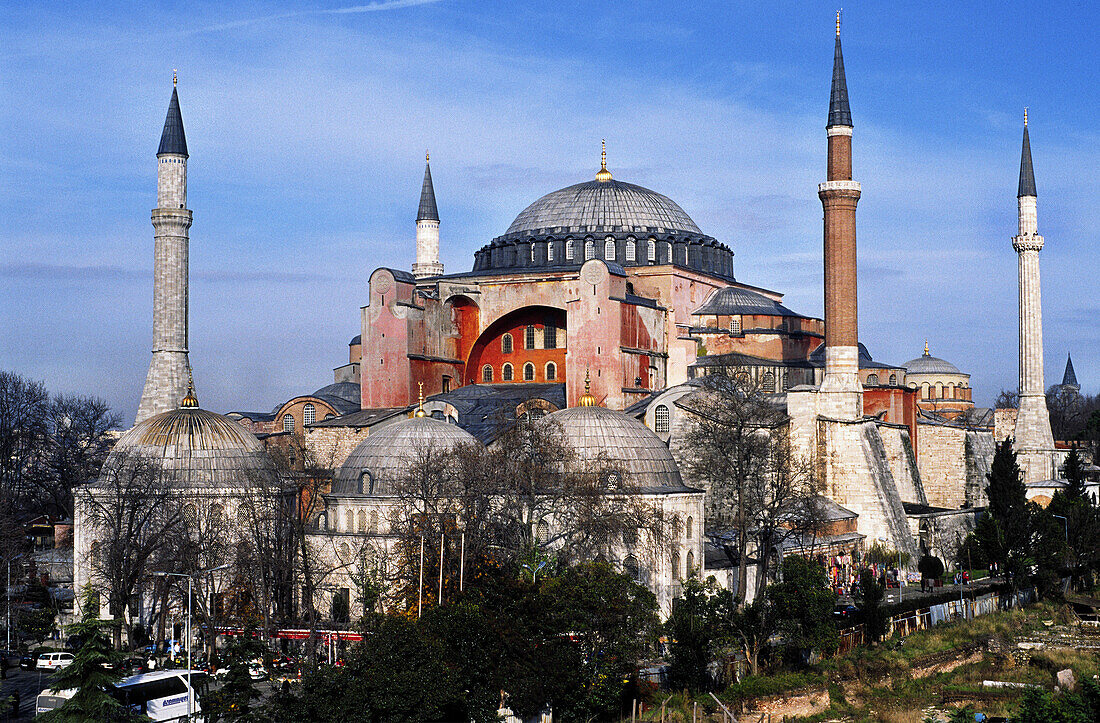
[35,670,207,721]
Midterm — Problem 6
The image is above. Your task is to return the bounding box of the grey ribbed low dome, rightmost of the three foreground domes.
[545,407,689,493]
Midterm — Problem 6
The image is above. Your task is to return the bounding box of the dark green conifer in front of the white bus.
[43,591,126,723]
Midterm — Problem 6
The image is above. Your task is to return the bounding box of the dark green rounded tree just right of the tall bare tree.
[769,556,839,661]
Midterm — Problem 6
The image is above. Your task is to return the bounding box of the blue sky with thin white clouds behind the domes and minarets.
[0,0,1100,421]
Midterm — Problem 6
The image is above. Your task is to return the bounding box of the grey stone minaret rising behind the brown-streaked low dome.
[134,73,191,424]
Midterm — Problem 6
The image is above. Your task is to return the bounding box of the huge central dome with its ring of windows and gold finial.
[474,148,734,278]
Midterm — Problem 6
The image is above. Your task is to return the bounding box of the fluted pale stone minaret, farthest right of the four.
[1012,110,1054,482]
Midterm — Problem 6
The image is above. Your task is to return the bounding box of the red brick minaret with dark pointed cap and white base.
[817,12,864,419]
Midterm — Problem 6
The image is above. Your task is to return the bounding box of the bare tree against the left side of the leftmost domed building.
[76,452,184,646]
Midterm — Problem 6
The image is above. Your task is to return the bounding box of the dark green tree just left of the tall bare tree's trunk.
[664,578,718,691]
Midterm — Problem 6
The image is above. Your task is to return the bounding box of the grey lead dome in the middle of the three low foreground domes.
[332,417,480,496]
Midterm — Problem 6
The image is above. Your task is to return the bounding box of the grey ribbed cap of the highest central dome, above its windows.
[504,180,703,237]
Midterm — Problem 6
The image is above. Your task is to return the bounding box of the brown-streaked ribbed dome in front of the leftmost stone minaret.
[102,407,275,486]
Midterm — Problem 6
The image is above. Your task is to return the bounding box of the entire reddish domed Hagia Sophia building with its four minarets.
[76,18,1057,613]
